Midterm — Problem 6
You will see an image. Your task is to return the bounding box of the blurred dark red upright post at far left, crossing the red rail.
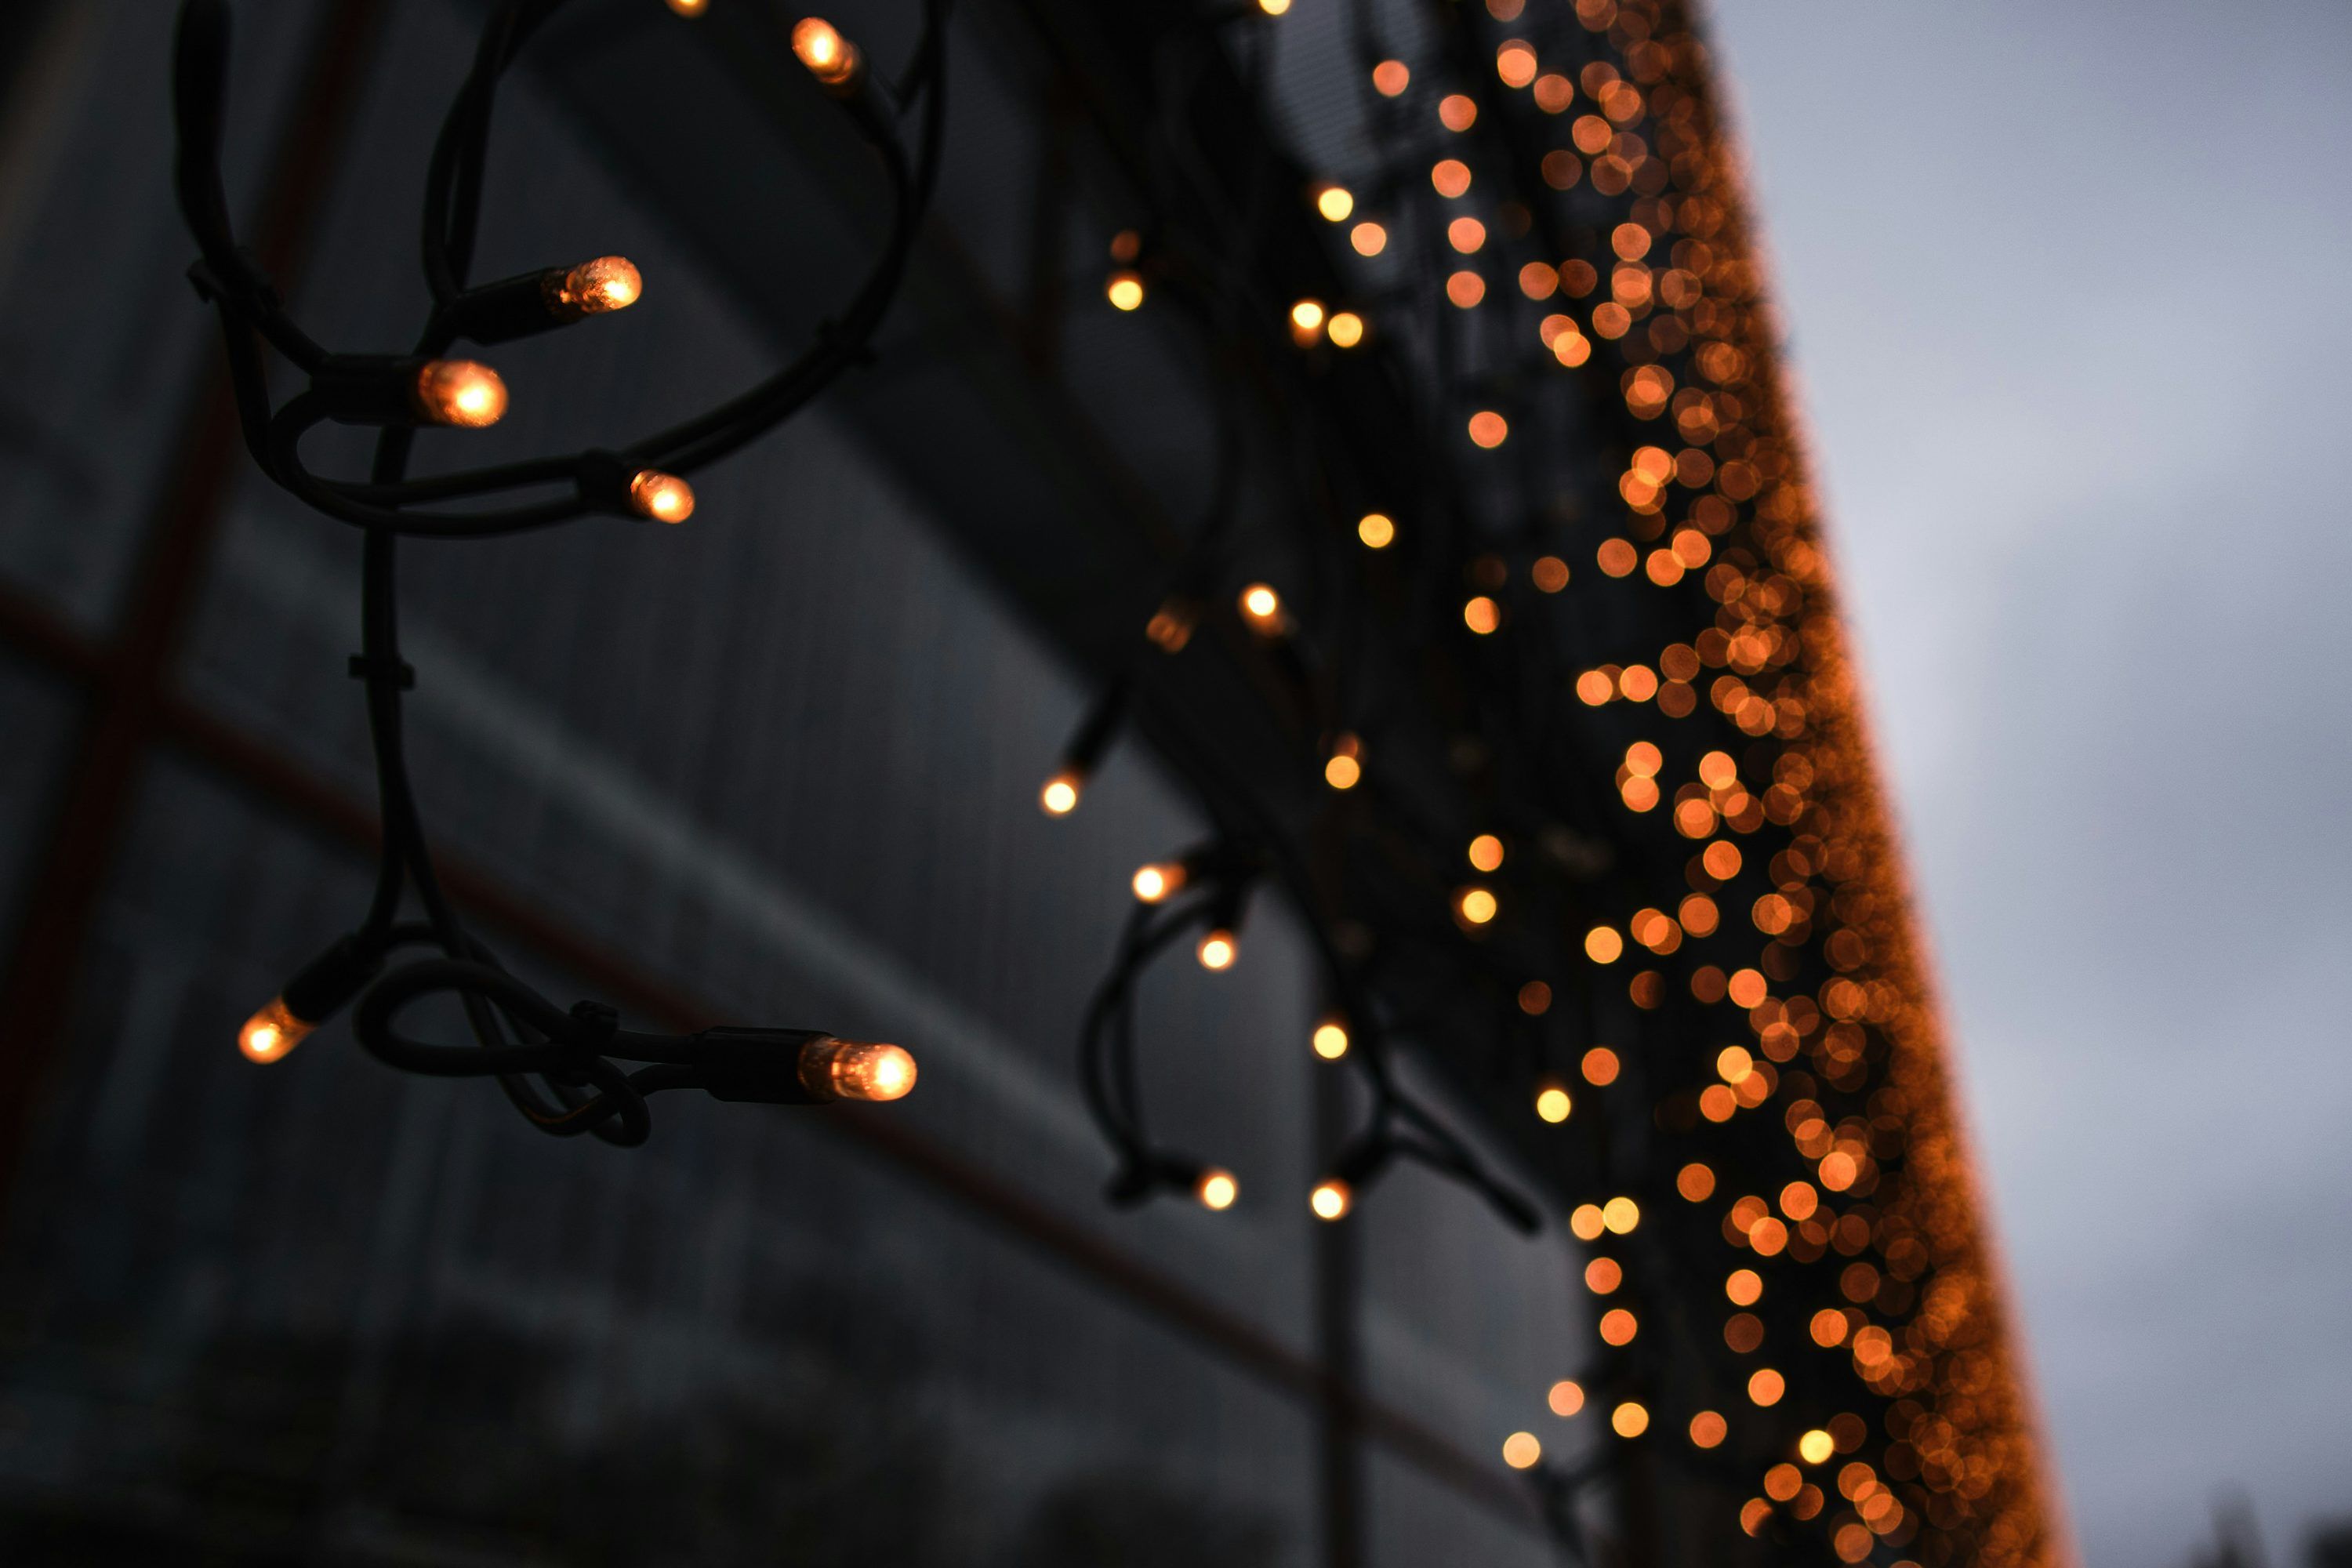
[0,0,383,1199]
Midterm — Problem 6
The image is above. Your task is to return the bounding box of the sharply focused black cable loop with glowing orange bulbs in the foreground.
[174,0,950,1145]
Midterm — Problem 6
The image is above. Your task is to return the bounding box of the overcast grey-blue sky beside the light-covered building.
[1715,0,2352,1568]
